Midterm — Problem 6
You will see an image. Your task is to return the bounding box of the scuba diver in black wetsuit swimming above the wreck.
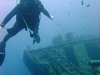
[0,0,54,66]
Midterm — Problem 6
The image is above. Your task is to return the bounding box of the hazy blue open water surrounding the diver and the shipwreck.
[0,0,100,75]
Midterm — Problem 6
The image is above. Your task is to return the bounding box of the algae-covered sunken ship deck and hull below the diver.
[23,38,100,75]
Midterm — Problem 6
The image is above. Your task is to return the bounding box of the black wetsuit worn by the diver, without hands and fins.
[2,2,51,44]
